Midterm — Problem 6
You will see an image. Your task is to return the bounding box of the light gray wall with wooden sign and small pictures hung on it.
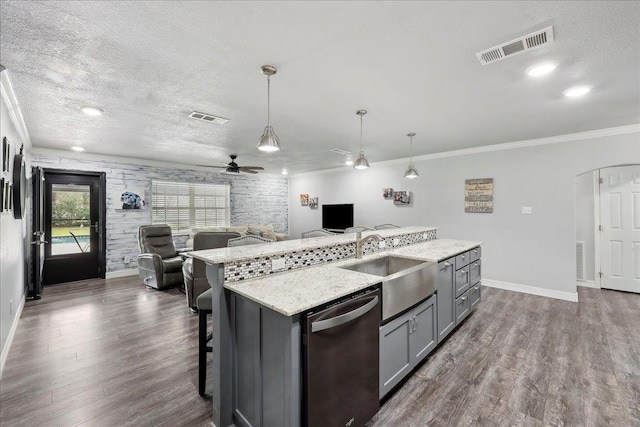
[289,127,640,299]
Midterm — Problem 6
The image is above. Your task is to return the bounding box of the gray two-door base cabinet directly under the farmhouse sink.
[380,295,437,398]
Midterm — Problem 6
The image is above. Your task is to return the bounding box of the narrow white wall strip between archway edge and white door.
[576,172,595,281]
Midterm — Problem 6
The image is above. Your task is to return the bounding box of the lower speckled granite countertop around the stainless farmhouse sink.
[225,239,482,316]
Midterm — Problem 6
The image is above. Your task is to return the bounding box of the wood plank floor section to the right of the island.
[370,288,640,427]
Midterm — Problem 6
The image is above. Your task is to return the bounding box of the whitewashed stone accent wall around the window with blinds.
[31,152,289,273]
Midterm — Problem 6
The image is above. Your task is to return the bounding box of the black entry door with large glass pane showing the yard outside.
[43,170,106,285]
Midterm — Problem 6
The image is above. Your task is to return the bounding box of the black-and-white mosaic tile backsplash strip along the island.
[224,230,437,283]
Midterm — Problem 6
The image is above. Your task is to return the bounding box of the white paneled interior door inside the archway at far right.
[600,165,640,293]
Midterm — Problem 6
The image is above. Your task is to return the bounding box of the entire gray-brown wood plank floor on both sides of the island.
[0,278,640,427]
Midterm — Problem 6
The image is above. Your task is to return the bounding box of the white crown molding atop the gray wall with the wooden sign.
[289,124,640,178]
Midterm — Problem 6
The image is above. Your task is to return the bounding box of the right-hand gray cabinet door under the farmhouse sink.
[409,295,438,366]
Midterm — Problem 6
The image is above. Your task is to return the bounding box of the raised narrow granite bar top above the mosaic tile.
[188,227,437,264]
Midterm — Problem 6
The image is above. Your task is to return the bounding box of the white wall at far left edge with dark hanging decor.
[0,72,31,375]
